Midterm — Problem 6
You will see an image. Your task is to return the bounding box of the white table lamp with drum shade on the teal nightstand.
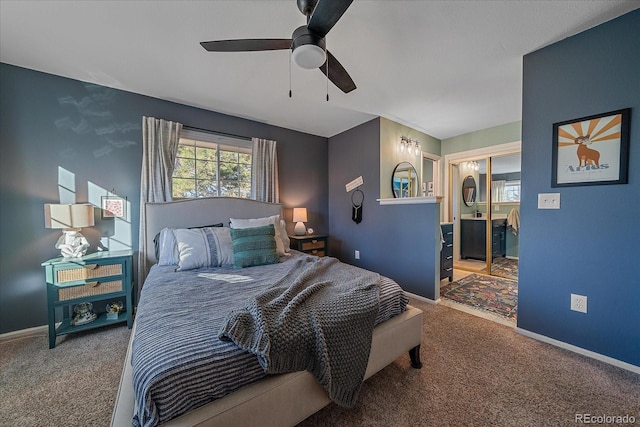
[44,204,94,258]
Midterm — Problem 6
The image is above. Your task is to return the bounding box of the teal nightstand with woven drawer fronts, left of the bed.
[42,251,133,348]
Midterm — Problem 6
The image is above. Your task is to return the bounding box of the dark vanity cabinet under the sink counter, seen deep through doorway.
[460,219,507,261]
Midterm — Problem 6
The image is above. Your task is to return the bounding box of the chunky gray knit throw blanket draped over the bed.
[218,257,380,407]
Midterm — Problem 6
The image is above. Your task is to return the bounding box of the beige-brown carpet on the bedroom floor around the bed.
[0,301,640,427]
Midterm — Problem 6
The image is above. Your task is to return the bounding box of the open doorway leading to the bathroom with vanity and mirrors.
[440,142,521,324]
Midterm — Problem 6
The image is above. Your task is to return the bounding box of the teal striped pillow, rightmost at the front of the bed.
[231,224,280,268]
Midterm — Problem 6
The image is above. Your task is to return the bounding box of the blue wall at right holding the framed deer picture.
[518,10,640,366]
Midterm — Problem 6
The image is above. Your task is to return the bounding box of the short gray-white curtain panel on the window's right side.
[251,138,280,203]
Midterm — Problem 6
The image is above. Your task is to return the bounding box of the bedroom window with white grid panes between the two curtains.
[171,129,252,199]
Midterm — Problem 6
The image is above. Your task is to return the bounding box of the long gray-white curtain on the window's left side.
[138,117,182,295]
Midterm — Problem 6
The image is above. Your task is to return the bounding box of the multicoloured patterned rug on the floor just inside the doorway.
[440,274,518,320]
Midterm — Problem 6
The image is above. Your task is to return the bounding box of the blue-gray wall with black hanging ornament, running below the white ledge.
[329,119,440,300]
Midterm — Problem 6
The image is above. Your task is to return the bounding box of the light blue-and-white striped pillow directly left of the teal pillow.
[173,227,233,271]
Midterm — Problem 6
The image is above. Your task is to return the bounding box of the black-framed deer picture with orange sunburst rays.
[551,108,631,187]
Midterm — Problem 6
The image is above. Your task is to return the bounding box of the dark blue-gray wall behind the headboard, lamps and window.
[0,64,329,333]
